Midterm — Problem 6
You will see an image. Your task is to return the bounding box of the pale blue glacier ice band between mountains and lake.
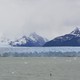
[0,47,80,57]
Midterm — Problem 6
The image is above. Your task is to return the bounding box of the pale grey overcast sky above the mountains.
[0,0,80,39]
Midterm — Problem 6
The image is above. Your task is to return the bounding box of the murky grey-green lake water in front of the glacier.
[0,57,80,80]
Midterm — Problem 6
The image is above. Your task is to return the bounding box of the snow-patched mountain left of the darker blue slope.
[10,33,48,47]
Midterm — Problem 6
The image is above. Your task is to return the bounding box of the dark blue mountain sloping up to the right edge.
[44,28,80,46]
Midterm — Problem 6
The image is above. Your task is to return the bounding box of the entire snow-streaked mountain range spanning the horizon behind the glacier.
[0,27,80,47]
